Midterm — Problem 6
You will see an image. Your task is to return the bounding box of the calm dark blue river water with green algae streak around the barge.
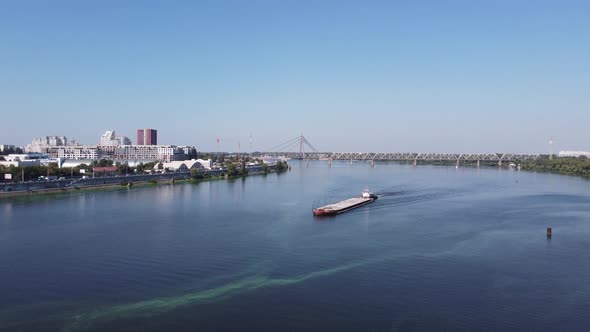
[0,161,590,331]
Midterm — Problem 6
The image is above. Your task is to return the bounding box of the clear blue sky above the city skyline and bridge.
[0,0,590,153]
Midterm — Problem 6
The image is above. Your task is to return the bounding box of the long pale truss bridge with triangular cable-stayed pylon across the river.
[253,134,539,164]
